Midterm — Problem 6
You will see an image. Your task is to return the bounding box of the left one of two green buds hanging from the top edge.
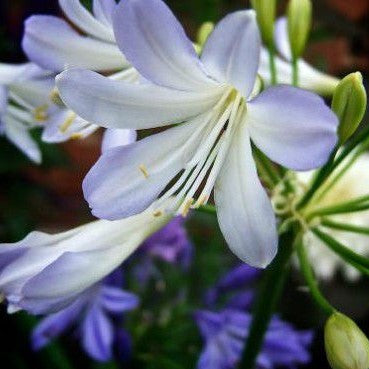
[251,0,277,47]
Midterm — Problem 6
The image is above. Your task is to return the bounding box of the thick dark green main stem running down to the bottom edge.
[239,233,293,369]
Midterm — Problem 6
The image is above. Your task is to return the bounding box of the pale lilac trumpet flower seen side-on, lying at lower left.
[0,204,170,314]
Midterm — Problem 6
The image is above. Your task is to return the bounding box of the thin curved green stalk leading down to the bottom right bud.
[297,236,336,316]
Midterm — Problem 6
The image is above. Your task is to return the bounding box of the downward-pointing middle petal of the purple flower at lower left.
[82,305,114,361]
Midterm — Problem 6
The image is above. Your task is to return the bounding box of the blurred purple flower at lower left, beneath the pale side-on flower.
[32,269,138,361]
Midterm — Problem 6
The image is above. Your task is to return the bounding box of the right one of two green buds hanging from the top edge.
[287,0,312,59]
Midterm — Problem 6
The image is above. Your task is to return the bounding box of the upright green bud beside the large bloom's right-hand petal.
[332,72,367,144]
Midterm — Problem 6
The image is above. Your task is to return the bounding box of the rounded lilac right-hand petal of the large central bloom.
[247,86,338,170]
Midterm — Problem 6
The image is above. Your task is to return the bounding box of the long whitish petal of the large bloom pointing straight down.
[214,124,278,268]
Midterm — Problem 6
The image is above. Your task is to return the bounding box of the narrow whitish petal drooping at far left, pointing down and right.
[4,116,42,164]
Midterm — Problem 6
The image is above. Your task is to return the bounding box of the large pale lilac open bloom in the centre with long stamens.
[57,0,337,267]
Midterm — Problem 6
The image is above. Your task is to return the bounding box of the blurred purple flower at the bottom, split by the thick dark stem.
[195,309,313,369]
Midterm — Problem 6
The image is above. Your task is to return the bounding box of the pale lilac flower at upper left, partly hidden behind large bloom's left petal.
[22,0,139,143]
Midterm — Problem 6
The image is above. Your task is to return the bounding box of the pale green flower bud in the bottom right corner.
[324,313,369,369]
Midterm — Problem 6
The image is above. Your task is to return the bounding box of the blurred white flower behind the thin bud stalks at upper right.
[259,17,339,95]
